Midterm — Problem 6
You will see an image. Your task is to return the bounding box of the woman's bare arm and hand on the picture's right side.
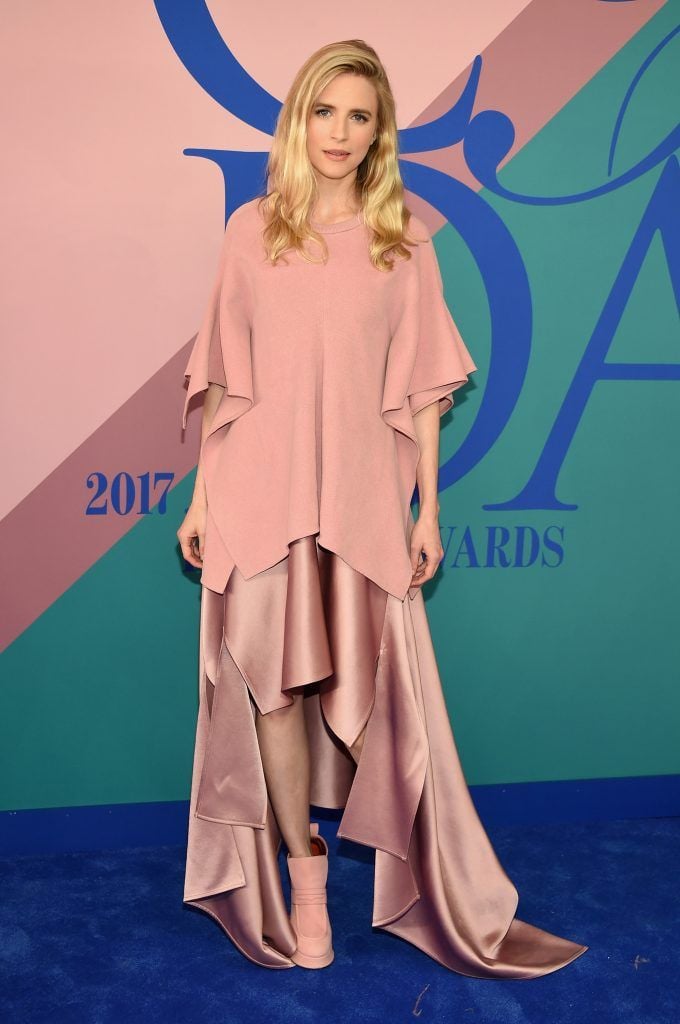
[411,401,443,587]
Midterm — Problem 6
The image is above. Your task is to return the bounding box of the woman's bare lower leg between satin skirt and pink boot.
[255,693,311,857]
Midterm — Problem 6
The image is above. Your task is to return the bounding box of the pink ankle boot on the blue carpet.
[288,821,335,968]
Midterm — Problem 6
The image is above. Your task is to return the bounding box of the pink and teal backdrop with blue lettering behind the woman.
[0,0,680,831]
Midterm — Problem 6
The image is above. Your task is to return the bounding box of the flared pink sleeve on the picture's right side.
[399,224,477,416]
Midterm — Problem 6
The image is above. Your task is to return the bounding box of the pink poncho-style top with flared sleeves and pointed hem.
[182,199,477,600]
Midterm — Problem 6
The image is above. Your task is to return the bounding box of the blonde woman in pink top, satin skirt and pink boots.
[178,40,588,978]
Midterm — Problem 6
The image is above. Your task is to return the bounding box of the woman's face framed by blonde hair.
[307,74,378,187]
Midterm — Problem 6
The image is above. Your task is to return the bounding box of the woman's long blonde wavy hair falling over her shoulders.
[259,39,425,270]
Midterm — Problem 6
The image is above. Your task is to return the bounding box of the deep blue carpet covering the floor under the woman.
[0,813,680,1024]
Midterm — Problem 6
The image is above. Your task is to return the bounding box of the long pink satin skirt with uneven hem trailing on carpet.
[184,535,588,979]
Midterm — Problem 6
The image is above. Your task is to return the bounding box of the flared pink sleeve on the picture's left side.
[182,210,253,427]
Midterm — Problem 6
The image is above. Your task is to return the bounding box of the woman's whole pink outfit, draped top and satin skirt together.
[183,201,588,979]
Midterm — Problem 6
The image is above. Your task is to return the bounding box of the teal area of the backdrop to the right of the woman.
[428,10,680,783]
